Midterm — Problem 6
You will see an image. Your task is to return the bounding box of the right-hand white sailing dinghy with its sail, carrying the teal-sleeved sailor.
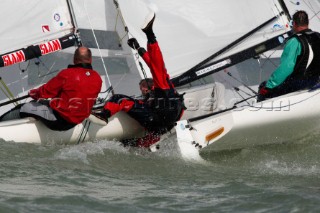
[114,0,320,158]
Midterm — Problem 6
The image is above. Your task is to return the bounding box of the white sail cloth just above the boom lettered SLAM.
[0,0,74,60]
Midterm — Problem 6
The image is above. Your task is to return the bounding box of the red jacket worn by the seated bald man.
[29,64,102,124]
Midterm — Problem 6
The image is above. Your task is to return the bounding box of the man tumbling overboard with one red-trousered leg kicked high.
[95,13,184,147]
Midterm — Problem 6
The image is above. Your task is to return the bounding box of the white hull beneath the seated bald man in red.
[0,112,145,144]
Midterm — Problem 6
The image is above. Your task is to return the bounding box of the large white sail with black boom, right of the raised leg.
[118,0,290,85]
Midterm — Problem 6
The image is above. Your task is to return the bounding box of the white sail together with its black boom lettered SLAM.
[0,0,76,67]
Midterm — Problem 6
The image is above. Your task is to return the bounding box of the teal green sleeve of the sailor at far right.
[266,37,301,89]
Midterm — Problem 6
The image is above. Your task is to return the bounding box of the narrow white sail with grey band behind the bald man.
[72,0,141,95]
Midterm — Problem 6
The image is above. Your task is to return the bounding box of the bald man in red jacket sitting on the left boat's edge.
[1,47,102,130]
